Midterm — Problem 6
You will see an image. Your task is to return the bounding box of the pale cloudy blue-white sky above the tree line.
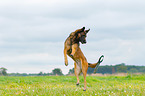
[0,0,145,74]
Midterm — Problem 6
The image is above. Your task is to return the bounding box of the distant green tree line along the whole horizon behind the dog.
[0,63,145,76]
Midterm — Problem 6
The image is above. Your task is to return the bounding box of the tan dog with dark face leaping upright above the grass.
[64,27,104,91]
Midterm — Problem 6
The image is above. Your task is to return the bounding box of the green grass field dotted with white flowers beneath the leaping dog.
[0,75,145,96]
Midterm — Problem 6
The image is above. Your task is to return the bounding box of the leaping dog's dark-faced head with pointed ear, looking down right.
[78,29,90,44]
